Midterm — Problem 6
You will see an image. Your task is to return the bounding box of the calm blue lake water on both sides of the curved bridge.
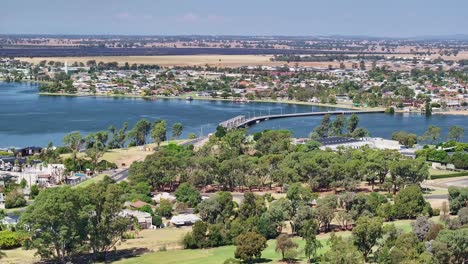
[0,82,468,147]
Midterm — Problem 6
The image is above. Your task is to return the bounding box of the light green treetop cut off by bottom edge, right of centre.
[323,233,364,264]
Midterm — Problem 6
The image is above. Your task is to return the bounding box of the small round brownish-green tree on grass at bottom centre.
[234,232,267,263]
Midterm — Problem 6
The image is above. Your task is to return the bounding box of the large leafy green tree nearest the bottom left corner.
[20,187,88,262]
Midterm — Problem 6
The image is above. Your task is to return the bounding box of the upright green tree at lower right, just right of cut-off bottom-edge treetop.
[352,216,383,260]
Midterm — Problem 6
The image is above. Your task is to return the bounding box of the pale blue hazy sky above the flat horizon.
[0,0,468,37]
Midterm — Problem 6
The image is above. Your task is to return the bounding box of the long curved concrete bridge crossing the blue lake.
[219,110,385,129]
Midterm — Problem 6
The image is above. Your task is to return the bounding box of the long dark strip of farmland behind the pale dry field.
[0,47,398,57]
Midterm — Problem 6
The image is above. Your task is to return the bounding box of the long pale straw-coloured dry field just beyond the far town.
[18,55,272,67]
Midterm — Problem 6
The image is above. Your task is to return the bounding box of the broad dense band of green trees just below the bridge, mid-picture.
[129,125,428,195]
